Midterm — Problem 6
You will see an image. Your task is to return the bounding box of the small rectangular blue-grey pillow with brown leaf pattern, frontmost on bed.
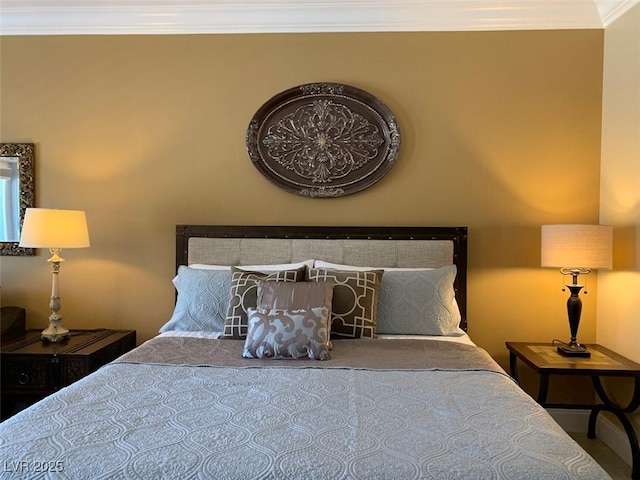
[242,307,329,360]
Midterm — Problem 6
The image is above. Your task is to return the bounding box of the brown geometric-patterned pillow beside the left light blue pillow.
[222,266,307,340]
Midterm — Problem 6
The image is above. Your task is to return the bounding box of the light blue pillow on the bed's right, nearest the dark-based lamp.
[377,265,464,335]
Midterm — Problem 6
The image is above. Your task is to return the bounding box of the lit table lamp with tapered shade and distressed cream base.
[20,208,89,342]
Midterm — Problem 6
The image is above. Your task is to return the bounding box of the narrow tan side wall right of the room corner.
[597,5,640,442]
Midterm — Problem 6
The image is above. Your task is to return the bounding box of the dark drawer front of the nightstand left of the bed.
[2,355,53,393]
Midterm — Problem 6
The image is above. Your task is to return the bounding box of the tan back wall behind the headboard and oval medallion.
[0,30,603,376]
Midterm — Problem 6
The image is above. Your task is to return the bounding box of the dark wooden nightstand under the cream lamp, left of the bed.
[0,329,136,420]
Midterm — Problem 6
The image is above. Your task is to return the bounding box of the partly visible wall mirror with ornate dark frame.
[0,143,35,255]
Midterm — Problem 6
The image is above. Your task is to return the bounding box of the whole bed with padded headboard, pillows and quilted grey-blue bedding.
[0,225,609,480]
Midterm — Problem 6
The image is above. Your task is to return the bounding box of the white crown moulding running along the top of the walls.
[0,0,640,35]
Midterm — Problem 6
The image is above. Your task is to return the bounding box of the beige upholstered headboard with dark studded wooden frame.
[176,225,467,331]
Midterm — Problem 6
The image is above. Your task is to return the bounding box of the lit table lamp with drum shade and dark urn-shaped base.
[541,225,613,357]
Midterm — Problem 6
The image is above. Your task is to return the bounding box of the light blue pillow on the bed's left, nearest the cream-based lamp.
[160,265,231,333]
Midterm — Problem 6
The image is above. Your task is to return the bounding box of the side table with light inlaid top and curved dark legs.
[506,342,640,480]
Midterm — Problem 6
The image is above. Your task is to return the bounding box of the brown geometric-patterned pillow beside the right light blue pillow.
[307,268,384,338]
